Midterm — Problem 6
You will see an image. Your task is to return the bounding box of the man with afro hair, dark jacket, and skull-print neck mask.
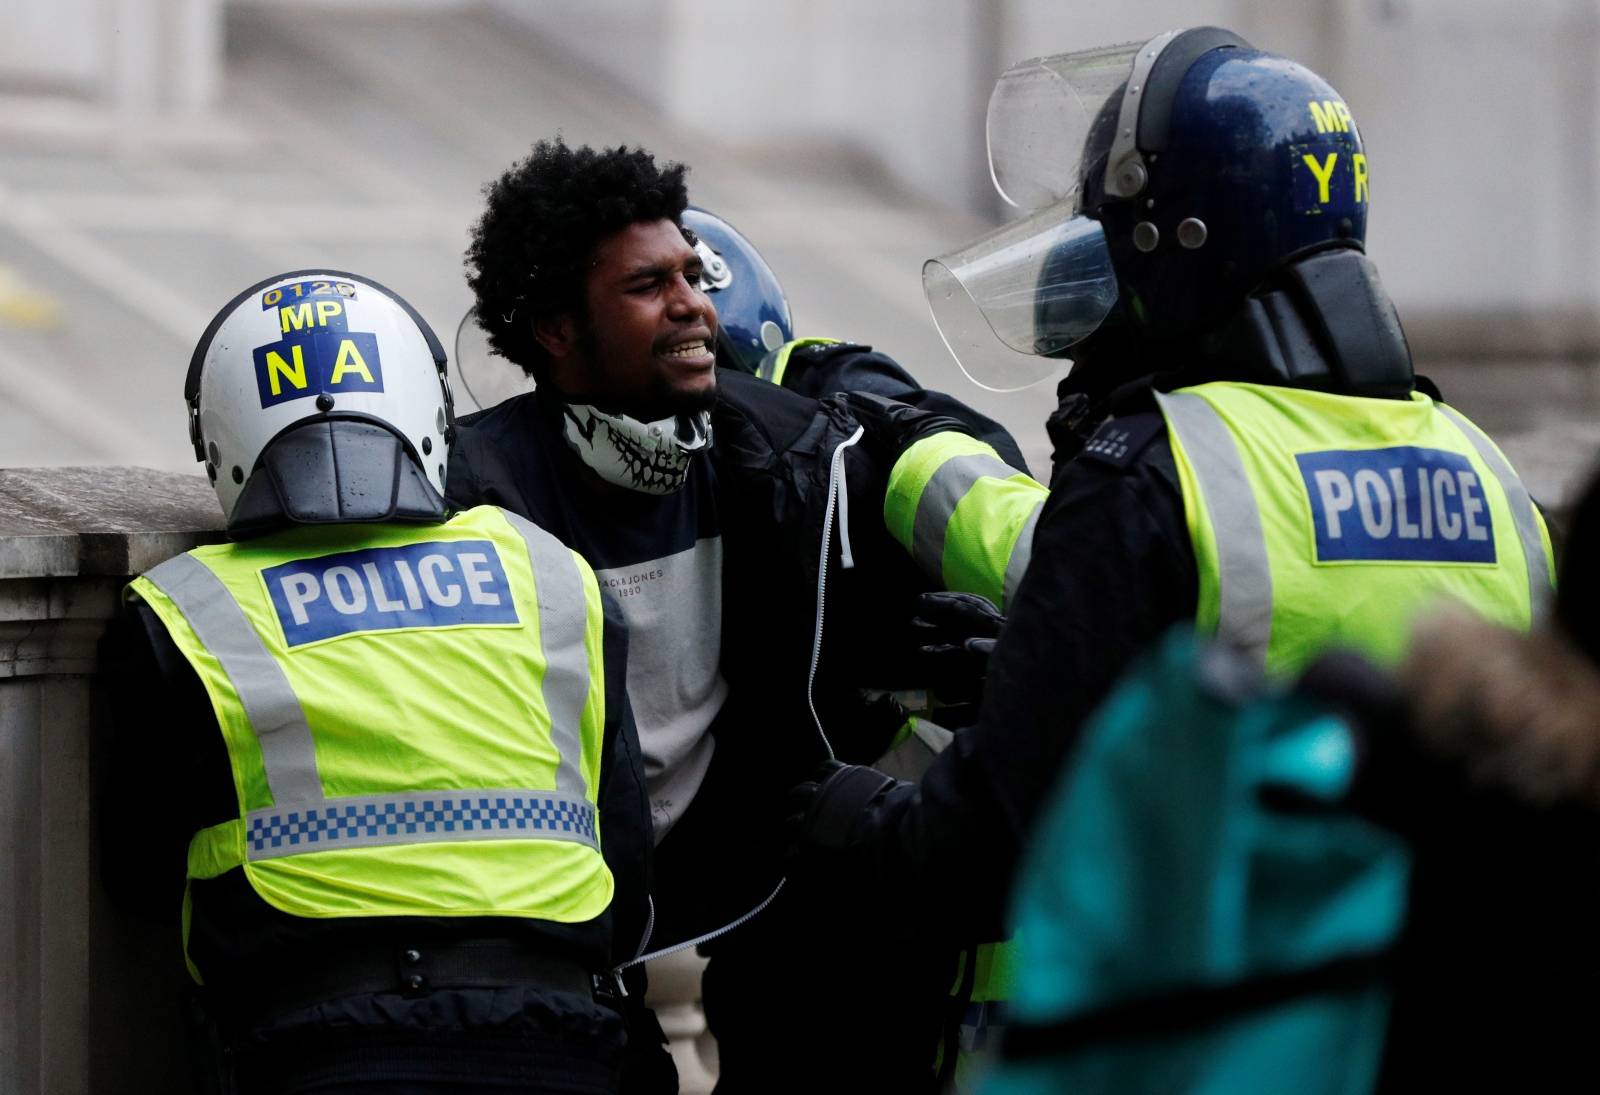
[448,138,1024,1092]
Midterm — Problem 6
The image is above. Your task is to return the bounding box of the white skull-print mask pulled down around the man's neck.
[562,403,710,495]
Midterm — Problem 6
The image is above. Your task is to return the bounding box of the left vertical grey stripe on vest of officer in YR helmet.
[1155,392,1272,664]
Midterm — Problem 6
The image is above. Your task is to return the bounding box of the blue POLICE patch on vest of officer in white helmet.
[261,539,520,647]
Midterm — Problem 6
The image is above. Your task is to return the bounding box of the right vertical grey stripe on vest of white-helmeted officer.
[499,509,600,802]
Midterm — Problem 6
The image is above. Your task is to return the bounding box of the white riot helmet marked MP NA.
[184,269,454,538]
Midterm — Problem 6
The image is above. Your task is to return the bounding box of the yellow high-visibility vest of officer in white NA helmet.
[128,506,613,977]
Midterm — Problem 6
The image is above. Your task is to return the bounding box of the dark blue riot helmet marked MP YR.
[1080,27,1366,336]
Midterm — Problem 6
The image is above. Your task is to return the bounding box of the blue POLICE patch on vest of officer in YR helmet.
[1294,445,1494,564]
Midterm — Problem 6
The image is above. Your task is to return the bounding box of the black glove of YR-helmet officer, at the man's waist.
[784,760,915,871]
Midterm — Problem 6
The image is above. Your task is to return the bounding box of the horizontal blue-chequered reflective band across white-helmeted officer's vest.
[245,789,598,860]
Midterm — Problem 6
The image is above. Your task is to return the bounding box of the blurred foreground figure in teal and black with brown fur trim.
[984,483,1600,1095]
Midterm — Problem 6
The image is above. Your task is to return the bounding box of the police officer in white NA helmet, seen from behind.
[106,269,674,1092]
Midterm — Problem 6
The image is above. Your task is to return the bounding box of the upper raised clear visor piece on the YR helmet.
[986,42,1144,210]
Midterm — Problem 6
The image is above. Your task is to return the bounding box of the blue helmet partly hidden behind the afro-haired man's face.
[683,205,794,373]
